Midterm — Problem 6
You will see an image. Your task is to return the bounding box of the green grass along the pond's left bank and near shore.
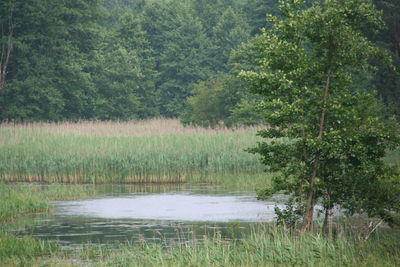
[0,183,400,266]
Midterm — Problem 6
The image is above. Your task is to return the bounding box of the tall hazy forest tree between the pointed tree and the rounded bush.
[143,1,212,117]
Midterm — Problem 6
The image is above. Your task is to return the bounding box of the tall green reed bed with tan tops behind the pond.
[0,119,264,183]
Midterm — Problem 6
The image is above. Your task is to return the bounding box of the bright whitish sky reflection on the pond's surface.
[54,193,282,222]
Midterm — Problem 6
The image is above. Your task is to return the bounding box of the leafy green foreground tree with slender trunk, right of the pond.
[241,0,399,231]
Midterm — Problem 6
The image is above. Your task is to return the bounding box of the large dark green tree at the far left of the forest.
[0,0,100,120]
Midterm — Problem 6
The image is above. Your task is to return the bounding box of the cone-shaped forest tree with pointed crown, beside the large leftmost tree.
[94,12,158,120]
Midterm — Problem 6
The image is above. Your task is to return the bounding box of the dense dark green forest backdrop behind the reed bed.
[0,0,400,123]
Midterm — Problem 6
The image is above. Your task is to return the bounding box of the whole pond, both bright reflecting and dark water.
[17,184,282,247]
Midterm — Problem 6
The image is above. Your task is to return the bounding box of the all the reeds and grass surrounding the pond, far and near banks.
[0,120,400,266]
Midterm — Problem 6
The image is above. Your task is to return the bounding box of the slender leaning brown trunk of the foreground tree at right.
[302,67,332,232]
